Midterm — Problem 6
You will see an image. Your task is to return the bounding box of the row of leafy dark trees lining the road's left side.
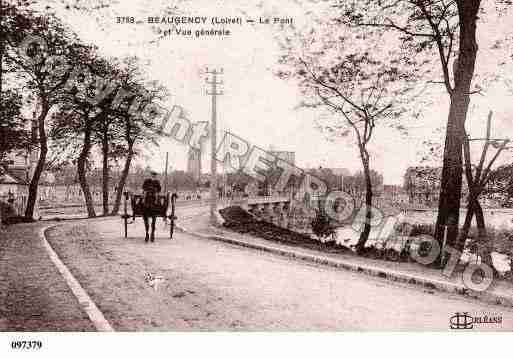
[2,0,167,218]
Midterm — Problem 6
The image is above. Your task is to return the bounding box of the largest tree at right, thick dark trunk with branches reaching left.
[330,0,510,256]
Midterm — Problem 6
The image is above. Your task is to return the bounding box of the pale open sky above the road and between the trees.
[35,0,513,184]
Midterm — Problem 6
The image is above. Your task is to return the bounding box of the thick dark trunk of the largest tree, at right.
[435,0,480,256]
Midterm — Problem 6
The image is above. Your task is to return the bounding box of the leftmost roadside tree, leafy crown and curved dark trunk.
[4,7,84,218]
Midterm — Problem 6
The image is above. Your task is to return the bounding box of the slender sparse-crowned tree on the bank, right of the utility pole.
[280,45,407,252]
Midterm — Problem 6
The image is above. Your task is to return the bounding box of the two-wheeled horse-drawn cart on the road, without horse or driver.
[121,192,178,239]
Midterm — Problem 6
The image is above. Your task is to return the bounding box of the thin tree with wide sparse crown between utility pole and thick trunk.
[279,30,413,252]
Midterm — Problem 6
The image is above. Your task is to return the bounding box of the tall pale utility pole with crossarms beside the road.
[206,68,223,225]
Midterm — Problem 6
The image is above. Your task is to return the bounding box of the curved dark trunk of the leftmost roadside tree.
[25,100,50,219]
